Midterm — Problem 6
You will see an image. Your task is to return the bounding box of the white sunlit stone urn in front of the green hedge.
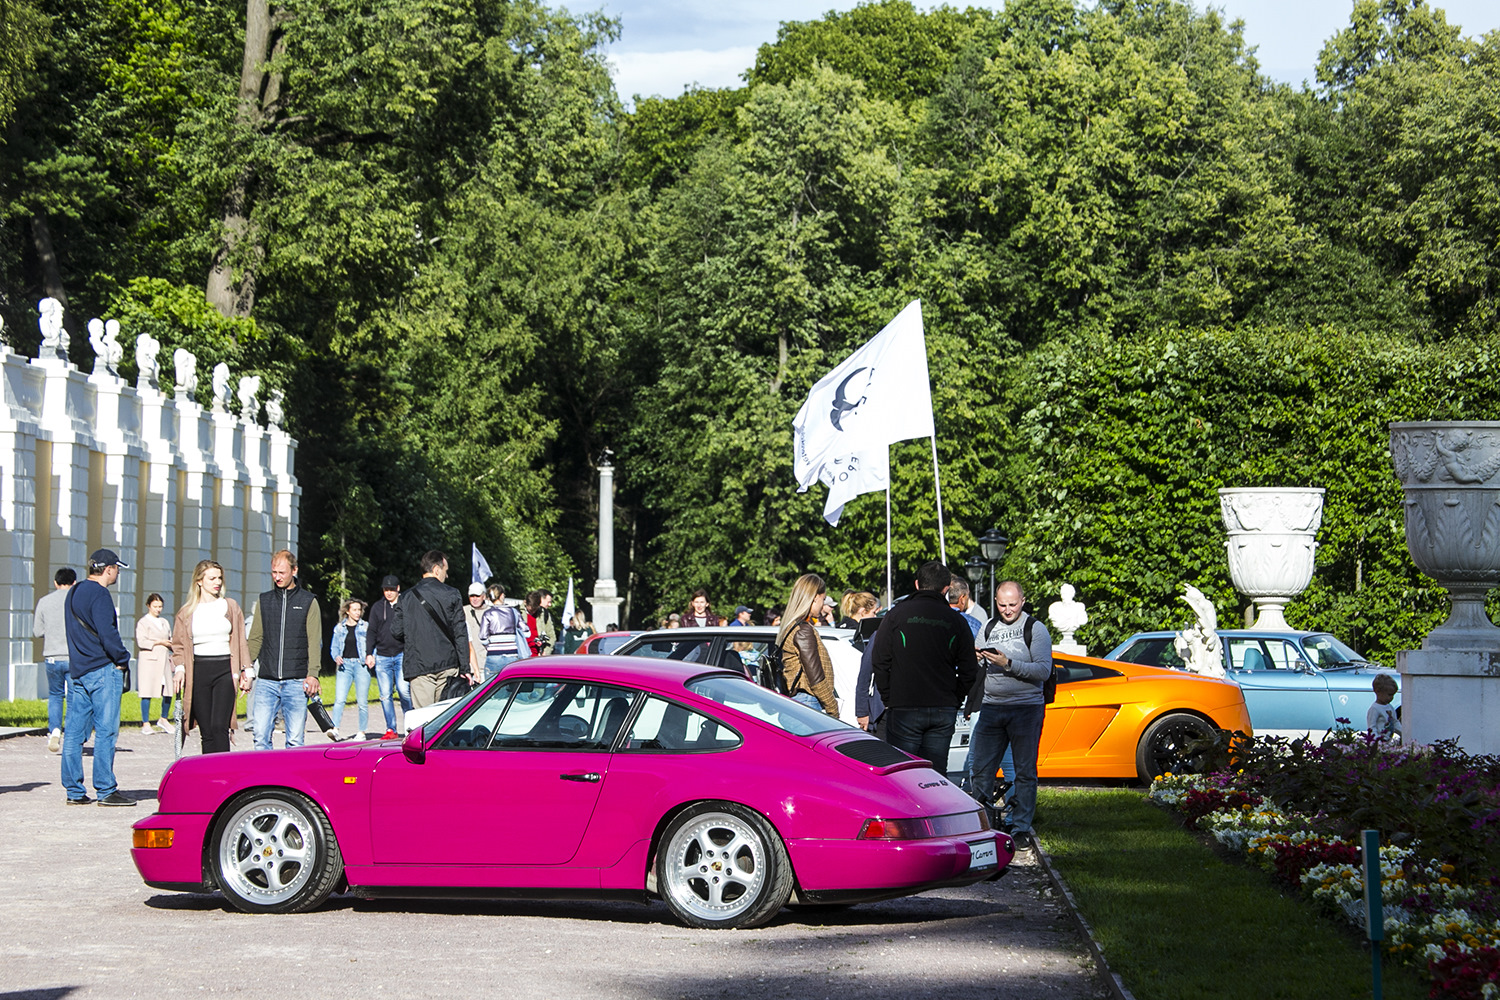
[1220,486,1323,630]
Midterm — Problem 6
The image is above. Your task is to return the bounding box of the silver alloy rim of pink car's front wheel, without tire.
[219,796,318,906]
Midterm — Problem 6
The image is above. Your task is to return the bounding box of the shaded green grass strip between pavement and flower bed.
[1037,789,1431,1000]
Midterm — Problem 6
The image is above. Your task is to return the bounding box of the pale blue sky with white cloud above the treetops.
[603,0,1500,103]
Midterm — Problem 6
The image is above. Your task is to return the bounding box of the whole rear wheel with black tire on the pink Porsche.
[656,802,792,928]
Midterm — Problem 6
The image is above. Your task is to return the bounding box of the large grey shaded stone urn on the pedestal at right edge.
[1391,420,1500,651]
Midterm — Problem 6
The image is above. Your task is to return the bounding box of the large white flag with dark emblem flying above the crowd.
[792,300,933,525]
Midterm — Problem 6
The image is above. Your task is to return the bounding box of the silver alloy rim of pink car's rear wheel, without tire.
[662,813,767,922]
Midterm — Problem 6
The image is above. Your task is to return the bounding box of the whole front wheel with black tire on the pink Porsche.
[209,789,344,913]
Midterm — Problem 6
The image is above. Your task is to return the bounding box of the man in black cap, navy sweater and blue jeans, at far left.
[63,549,135,805]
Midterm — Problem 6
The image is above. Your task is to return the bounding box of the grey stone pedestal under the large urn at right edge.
[1392,649,1500,754]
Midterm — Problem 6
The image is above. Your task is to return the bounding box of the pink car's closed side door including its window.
[371,681,635,865]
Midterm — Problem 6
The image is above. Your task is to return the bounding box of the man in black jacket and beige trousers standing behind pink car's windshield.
[390,550,479,708]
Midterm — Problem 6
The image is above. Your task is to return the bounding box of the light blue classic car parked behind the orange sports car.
[1104,628,1400,739]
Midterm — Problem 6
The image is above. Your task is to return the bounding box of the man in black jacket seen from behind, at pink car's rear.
[870,561,980,774]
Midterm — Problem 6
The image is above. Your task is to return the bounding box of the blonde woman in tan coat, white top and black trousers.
[173,559,252,754]
